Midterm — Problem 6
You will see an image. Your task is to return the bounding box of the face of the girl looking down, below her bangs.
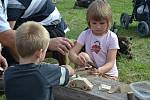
[90,19,108,35]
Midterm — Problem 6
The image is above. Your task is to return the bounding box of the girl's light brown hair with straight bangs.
[86,0,112,29]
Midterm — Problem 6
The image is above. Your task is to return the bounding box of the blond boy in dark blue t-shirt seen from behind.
[4,21,74,100]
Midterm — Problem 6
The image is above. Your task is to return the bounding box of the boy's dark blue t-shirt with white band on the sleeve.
[4,64,69,100]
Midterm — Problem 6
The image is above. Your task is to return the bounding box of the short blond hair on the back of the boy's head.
[16,21,50,57]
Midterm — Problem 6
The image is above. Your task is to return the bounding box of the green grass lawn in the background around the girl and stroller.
[0,0,150,100]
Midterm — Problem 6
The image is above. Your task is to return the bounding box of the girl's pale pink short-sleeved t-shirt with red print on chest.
[77,29,120,76]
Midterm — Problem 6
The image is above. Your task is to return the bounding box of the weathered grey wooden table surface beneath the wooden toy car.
[54,72,128,100]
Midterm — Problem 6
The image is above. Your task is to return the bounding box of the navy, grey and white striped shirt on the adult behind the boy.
[7,0,67,32]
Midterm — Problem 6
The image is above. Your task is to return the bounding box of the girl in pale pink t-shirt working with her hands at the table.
[69,0,119,80]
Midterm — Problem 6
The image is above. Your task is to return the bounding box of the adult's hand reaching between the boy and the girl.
[48,37,74,55]
